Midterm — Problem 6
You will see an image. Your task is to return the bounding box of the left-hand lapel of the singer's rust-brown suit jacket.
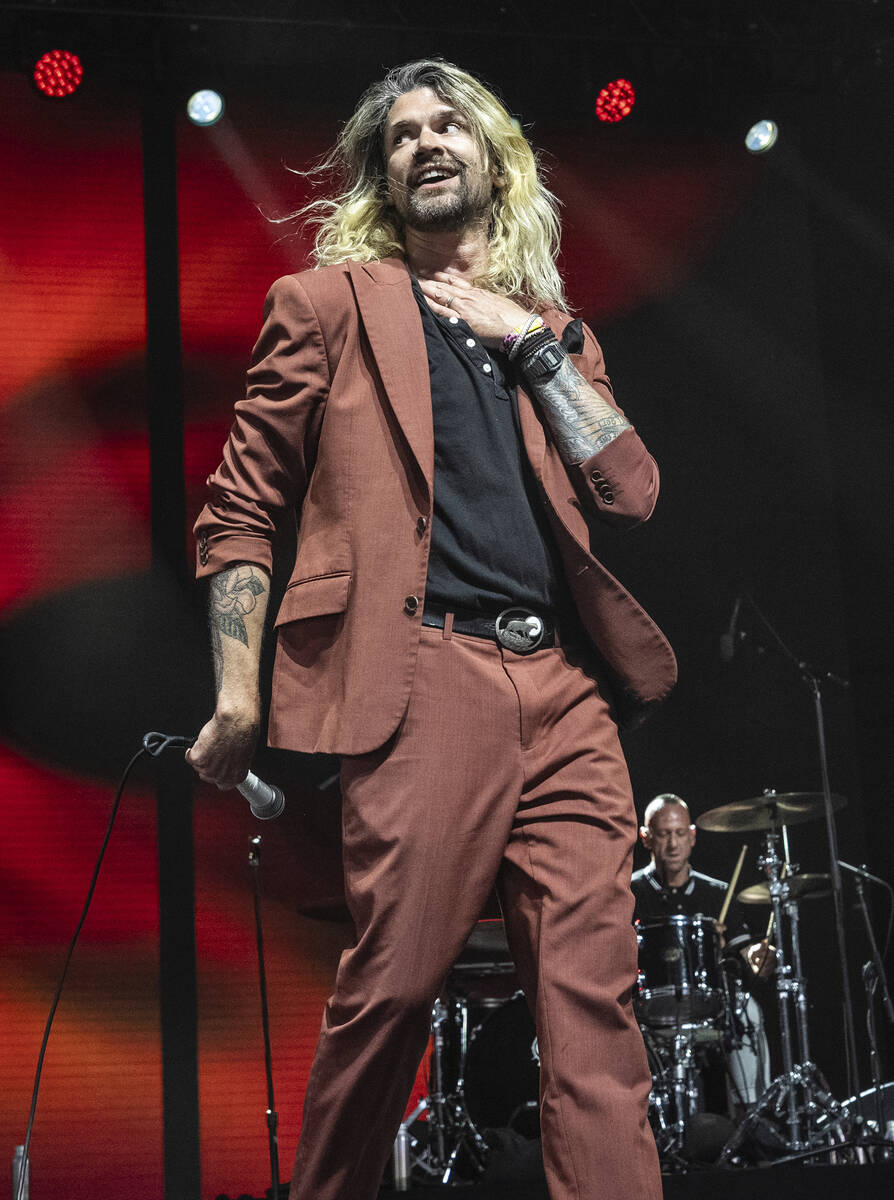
[348,258,434,492]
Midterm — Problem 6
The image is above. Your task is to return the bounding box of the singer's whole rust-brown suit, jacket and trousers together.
[196,260,674,1200]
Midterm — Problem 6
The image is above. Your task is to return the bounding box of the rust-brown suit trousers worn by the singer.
[290,629,661,1200]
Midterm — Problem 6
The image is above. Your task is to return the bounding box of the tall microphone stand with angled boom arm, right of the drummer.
[738,592,859,1097]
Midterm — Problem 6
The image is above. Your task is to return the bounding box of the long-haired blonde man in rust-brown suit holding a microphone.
[187,60,676,1200]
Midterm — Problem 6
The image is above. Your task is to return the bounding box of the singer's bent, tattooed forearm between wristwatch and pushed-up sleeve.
[526,359,630,464]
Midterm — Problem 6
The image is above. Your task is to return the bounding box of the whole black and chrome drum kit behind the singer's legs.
[394,791,894,1190]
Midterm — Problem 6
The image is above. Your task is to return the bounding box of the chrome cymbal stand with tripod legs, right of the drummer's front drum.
[718,825,848,1166]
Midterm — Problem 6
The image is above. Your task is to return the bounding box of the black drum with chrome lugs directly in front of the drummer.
[634,916,724,1028]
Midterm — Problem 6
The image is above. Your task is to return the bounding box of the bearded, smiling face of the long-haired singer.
[384,88,493,233]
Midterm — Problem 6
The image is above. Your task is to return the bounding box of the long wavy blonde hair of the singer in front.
[295,59,565,308]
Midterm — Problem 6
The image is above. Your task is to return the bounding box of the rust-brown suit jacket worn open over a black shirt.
[196,259,676,755]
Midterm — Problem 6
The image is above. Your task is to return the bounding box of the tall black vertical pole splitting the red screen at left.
[143,89,200,1200]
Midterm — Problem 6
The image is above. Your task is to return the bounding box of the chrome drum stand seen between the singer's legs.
[395,998,490,1188]
